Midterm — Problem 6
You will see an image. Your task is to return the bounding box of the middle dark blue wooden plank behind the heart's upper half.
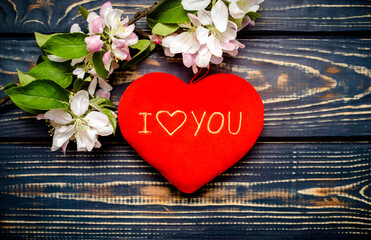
[0,37,371,137]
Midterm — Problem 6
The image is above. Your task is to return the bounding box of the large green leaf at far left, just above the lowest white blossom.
[5,80,70,113]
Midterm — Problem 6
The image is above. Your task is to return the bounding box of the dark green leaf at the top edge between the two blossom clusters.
[147,0,189,28]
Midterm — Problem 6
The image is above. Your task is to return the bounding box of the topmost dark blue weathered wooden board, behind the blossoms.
[0,0,371,33]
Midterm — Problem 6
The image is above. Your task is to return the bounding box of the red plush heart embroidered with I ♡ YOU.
[118,73,264,193]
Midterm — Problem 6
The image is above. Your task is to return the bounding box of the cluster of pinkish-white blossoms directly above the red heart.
[162,9,244,73]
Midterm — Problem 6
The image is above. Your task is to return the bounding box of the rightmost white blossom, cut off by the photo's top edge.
[228,0,264,19]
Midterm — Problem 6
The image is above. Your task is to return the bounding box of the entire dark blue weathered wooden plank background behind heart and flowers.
[0,0,371,239]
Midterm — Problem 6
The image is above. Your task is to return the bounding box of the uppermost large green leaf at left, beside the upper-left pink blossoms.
[41,33,89,59]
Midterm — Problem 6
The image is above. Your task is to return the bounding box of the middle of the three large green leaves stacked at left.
[28,61,73,88]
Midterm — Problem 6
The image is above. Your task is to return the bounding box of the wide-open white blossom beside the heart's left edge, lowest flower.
[39,90,113,152]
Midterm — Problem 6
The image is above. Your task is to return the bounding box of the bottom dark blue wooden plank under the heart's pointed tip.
[0,142,371,239]
